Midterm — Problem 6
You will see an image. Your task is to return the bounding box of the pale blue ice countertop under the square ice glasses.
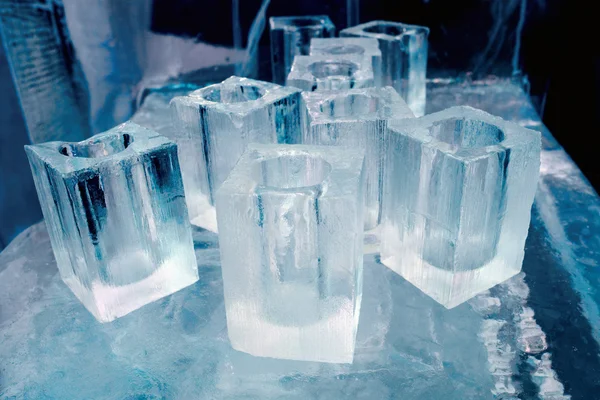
[0,80,600,400]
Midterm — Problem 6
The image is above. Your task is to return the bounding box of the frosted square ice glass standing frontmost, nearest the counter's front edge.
[217,145,364,363]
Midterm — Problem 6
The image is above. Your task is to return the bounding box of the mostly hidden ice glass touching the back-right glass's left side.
[310,37,383,87]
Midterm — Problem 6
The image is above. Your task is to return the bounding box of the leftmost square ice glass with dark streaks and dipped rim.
[25,123,198,322]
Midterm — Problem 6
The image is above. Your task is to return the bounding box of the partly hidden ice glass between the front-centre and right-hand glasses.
[302,86,414,230]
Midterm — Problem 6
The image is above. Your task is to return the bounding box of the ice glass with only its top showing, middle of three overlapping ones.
[287,54,375,92]
